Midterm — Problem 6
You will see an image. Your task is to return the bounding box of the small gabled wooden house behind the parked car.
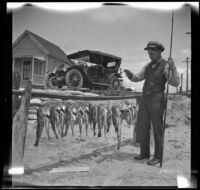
[12,30,73,87]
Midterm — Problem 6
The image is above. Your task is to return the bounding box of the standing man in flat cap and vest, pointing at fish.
[125,41,180,165]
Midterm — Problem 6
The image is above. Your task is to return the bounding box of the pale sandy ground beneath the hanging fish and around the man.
[13,96,191,186]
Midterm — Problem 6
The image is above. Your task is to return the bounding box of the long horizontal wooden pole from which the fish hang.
[12,89,141,101]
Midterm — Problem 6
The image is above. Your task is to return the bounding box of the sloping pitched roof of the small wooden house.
[13,30,72,64]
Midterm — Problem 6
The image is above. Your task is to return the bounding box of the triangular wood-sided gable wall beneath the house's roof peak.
[13,36,44,57]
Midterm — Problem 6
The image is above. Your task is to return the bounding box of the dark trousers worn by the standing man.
[137,92,165,158]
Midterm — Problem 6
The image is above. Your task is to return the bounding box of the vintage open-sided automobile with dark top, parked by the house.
[45,50,123,90]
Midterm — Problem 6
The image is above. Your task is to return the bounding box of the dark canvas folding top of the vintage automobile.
[67,50,122,67]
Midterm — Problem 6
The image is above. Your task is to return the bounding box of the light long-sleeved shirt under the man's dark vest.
[130,59,180,87]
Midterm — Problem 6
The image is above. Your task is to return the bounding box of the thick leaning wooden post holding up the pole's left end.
[12,80,32,168]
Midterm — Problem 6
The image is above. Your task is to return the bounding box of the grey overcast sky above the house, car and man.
[10,4,191,91]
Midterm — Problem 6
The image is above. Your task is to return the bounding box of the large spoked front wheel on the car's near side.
[65,69,83,89]
